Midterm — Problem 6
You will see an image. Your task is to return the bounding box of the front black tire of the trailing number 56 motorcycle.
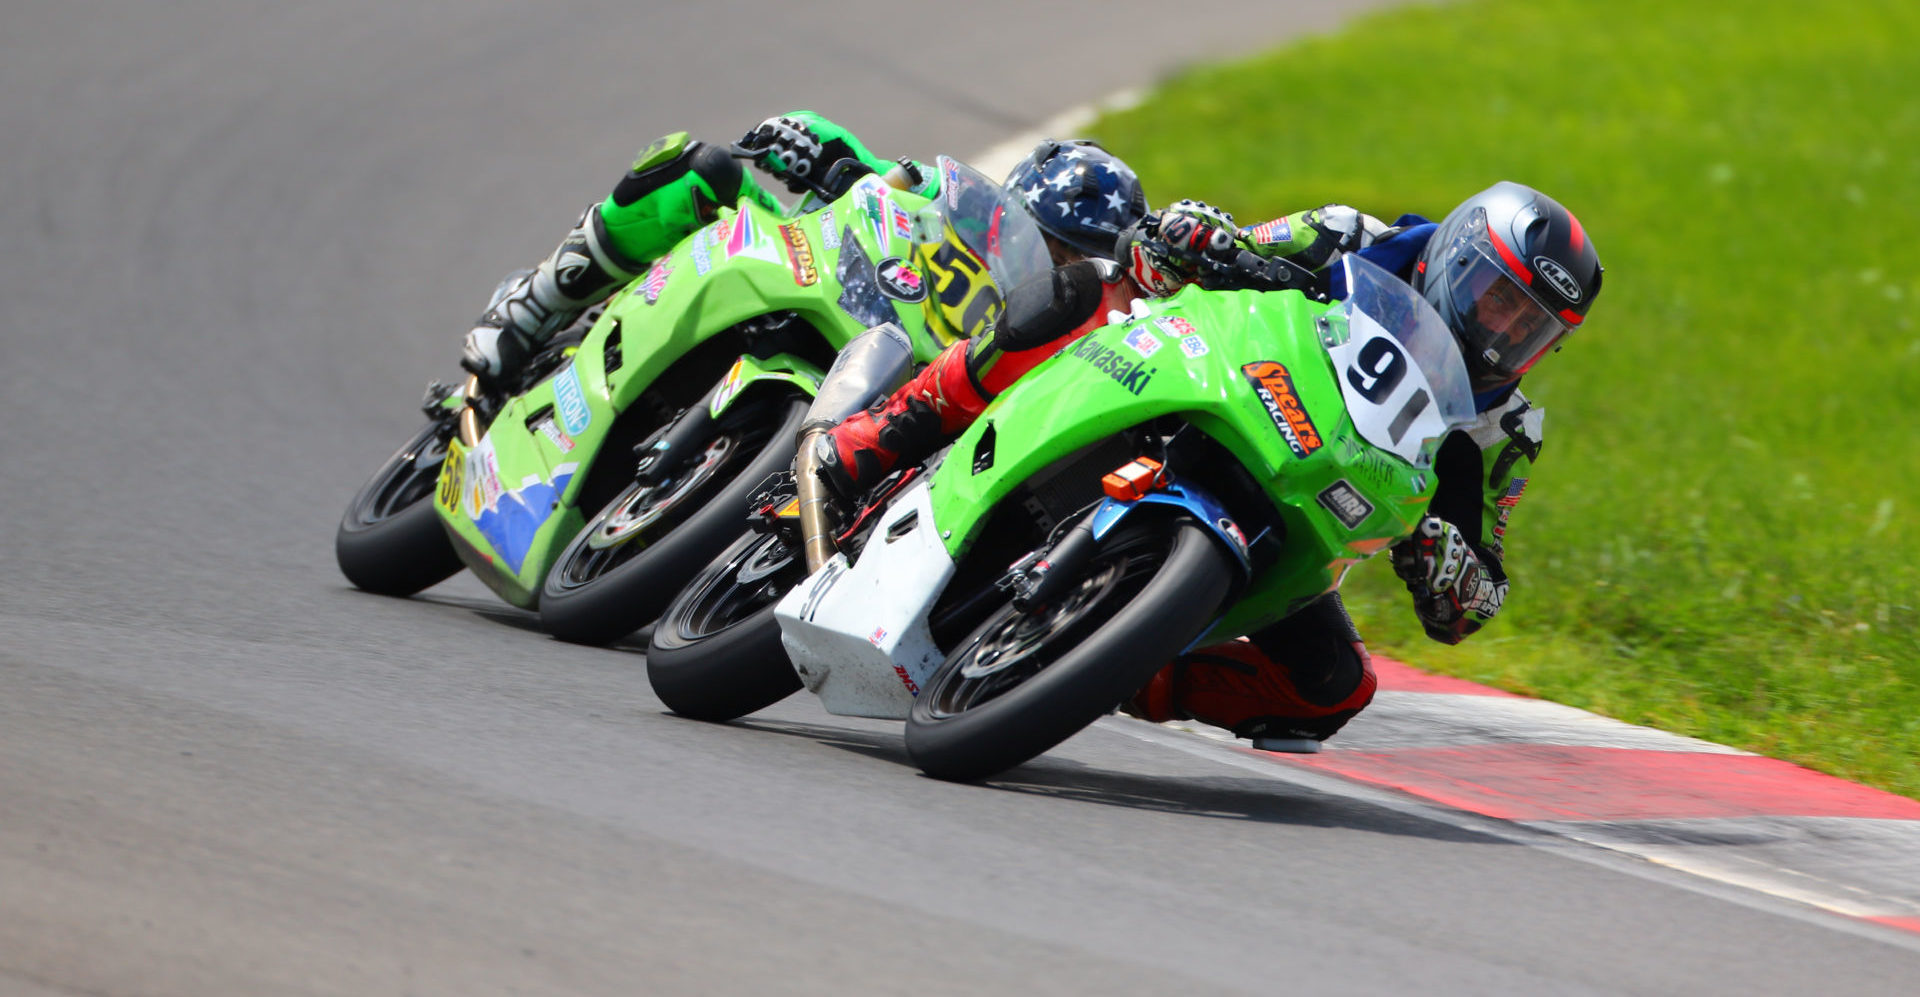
[540,394,808,644]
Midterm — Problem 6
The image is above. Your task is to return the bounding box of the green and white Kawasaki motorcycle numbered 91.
[647,249,1475,780]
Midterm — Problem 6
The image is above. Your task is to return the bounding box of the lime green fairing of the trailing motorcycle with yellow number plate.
[436,181,941,607]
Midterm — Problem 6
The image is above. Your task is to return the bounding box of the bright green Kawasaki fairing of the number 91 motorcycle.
[933,286,1434,640]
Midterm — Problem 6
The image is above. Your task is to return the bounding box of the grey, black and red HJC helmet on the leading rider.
[1413,181,1601,392]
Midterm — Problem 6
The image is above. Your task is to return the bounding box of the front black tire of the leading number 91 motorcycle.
[906,519,1236,782]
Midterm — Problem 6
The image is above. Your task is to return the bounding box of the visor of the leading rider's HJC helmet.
[1448,223,1572,377]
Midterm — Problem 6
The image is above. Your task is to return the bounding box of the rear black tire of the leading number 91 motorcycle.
[647,534,806,722]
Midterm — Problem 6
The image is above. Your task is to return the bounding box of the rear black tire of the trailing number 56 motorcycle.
[334,423,461,596]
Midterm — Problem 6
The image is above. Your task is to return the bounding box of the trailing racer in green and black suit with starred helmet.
[461,111,1146,384]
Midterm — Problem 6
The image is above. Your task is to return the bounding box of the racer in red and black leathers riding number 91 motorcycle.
[818,182,1601,751]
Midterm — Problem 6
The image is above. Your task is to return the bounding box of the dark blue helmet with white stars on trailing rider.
[1006,138,1146,259]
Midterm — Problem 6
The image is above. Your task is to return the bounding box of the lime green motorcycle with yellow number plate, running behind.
[336,150,1046,644]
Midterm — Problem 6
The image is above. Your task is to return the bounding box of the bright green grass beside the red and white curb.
[1092,0,1920,797]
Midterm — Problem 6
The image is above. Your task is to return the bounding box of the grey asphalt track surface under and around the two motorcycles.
[0,0,1920,997]
